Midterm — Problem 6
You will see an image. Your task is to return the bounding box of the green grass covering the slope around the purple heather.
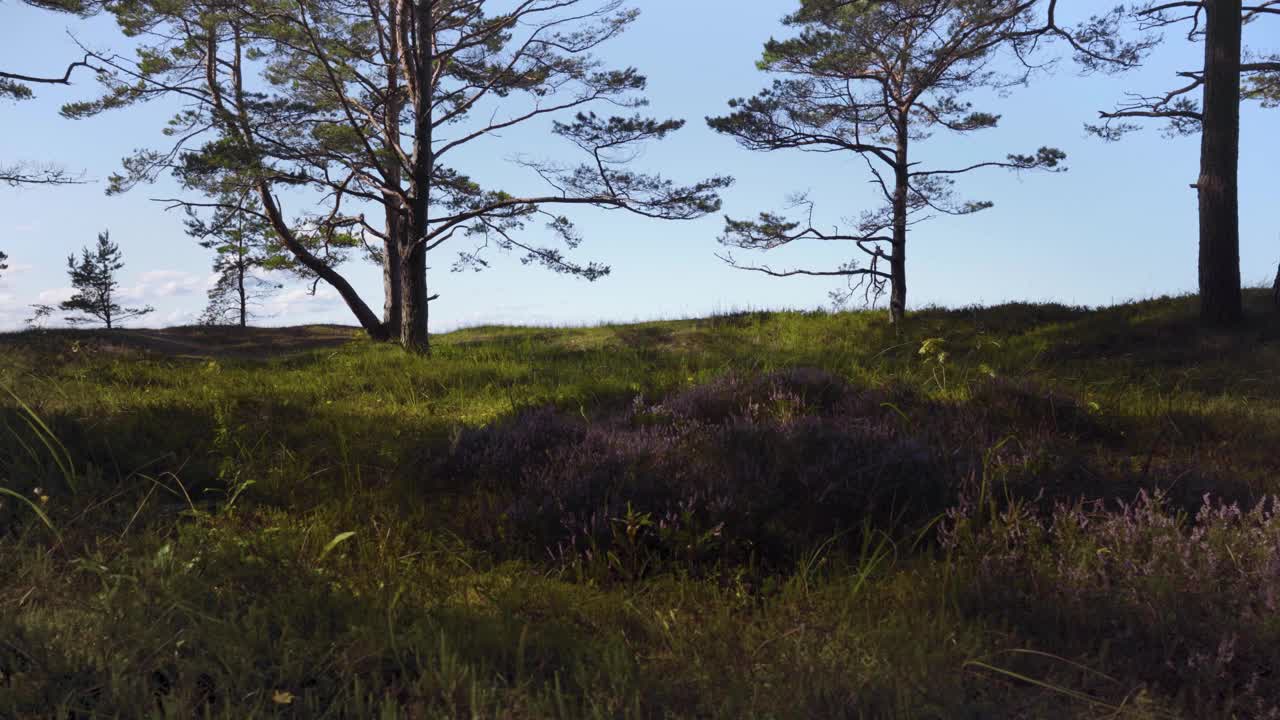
[0,292,1280,719]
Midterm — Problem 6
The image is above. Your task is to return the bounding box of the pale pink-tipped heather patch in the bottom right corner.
[940,492,1280,719]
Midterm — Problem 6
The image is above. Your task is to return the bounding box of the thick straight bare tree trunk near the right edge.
[1196,0,1244,327]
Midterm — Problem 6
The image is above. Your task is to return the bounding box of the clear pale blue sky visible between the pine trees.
[0,0,1280,332]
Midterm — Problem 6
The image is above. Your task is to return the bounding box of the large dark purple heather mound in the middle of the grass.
[440,369,956,570]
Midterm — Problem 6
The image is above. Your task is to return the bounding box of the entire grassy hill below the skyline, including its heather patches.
[0,292,1280,719]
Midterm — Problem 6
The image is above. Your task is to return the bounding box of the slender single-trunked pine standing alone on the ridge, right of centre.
[708,0,1087,323]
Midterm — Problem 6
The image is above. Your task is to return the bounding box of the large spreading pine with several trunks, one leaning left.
[63,0,730,352]
